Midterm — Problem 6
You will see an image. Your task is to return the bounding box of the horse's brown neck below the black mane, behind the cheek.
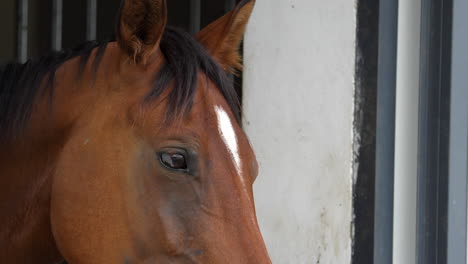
[0,45,113,263]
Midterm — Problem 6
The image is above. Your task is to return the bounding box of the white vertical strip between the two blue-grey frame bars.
[393,0,421,264]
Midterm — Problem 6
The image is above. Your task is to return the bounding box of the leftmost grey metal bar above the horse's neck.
[17,0,29,63]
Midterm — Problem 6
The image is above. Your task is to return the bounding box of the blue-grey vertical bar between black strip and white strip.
[374,0,398,264]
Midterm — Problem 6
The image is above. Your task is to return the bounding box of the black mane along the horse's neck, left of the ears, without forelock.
[0,41,107,140]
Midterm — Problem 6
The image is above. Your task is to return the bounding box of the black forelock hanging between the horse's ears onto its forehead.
[146,27,240,122]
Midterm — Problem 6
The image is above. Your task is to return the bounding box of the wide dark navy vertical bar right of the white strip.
[416,0,452,264]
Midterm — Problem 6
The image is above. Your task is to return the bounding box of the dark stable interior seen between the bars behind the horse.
[0,0,236,63]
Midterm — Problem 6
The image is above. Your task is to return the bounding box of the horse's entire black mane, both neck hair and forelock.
[0,27,240,141]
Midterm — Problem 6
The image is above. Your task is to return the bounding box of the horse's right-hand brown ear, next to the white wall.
[196,0,255,73]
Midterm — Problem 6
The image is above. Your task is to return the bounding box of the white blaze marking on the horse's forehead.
[215,106,244,178]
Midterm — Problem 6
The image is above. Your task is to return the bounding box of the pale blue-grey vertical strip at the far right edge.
[446,0,468,264]
